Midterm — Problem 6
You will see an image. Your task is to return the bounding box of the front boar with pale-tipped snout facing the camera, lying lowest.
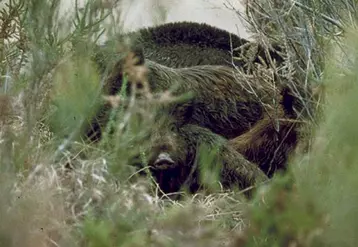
[138,116,268,198]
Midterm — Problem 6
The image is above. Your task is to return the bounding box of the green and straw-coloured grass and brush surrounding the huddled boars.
[0,0,358,247]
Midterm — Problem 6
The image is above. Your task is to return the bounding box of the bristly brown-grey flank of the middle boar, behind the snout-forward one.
[107,60,280,138]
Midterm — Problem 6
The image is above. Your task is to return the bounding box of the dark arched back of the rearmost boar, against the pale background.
[105,22,283,71]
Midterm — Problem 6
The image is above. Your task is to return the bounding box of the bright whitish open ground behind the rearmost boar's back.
[56,0,251,39]
